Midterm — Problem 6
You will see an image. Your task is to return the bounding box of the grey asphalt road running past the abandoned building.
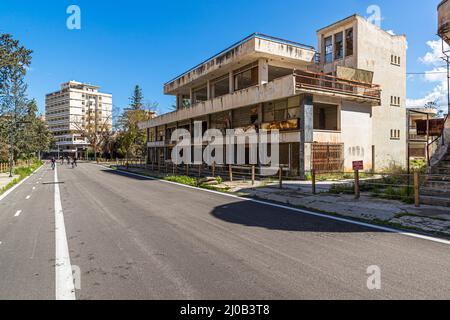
[0,164,450,299]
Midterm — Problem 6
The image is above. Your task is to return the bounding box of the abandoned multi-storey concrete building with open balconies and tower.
[140,15,407,177]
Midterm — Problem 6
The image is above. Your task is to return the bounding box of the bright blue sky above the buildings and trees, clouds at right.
[0,0,447,113]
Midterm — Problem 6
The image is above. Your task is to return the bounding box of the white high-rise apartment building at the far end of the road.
[45,81,112,157]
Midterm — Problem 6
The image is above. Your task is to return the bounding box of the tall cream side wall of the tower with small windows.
[356,18,407,170]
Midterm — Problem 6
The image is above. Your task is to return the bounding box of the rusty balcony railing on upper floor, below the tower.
[294,71,381,100]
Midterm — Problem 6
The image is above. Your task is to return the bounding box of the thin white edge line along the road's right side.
[108,165,450,245]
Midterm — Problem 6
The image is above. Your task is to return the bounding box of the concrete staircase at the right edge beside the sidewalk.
[420,150,450,207]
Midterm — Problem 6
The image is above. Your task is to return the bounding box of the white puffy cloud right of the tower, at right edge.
[406,40,448,107]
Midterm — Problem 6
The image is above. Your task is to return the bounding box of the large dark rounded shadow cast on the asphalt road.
[211,201,385,233]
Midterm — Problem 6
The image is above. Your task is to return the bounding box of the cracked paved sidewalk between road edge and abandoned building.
[114,167,450,236]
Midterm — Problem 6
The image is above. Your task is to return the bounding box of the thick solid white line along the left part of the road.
[55,166,76,300]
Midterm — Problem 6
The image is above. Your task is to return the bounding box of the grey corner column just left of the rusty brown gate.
[299,95,314,178]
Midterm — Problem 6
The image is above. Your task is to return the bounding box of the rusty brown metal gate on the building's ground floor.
[311,143,344,173]
